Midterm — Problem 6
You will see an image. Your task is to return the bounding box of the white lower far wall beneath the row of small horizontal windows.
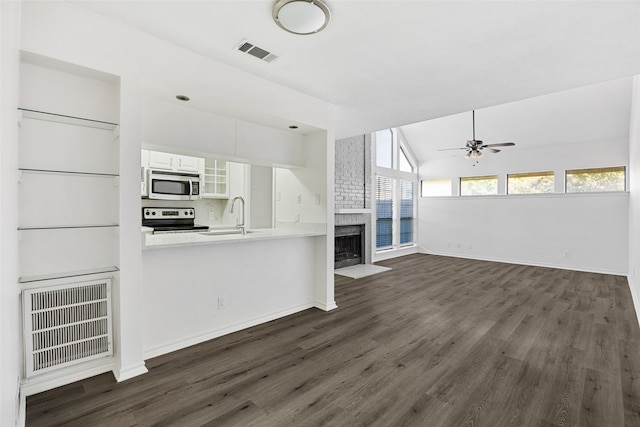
[418,193,629,275]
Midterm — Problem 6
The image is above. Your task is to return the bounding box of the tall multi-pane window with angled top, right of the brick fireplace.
[374,129,417,250]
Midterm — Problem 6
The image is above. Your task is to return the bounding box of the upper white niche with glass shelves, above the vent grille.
[18,63,120,286]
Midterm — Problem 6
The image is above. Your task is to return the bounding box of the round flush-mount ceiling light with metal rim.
[273,0,331,35]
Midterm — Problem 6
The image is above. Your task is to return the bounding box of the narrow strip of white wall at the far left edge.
[0,1,25,426]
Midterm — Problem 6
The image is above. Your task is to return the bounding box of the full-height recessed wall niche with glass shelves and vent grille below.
[17,56,120,395]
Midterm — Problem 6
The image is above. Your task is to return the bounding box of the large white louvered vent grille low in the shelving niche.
[23,279,113,378]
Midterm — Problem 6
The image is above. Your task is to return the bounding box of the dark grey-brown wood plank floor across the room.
[27,255,640,427]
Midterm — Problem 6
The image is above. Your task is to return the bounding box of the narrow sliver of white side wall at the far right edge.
[628,75,640,318]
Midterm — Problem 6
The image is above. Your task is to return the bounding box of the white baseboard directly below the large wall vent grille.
[20,357,114,397]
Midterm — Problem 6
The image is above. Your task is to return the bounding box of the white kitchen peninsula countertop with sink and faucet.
[141,224,327,249]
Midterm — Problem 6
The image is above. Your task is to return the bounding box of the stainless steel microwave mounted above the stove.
[147,171,200,200]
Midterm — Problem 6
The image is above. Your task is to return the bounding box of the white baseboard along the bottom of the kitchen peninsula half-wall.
[143,303,315,360]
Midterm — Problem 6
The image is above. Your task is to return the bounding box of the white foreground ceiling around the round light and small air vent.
[75,0,640,144]
